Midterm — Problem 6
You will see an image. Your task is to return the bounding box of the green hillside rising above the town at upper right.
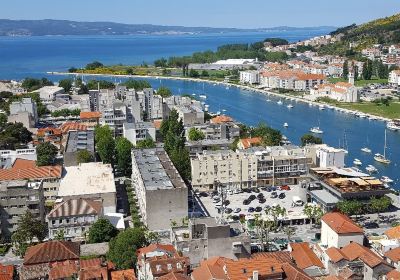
[320,14,400,56]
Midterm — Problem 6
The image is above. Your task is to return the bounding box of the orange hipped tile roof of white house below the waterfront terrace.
[321,212,364,234]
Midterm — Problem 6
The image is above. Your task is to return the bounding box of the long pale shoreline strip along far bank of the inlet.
[47,72,391,122]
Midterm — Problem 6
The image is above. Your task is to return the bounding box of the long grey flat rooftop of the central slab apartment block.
[132,148,186,190]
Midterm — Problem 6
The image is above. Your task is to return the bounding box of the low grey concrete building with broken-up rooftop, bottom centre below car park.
[171,217,251,267]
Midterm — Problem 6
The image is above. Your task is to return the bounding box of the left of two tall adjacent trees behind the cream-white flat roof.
[94,125,115,164]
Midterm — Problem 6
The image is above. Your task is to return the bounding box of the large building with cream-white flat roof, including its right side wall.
[58,162,117,213]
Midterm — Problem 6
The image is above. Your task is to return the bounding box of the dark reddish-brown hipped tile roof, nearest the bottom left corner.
[24,241,80,265]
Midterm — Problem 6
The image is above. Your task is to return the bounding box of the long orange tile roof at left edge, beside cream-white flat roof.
[0,165,62,181]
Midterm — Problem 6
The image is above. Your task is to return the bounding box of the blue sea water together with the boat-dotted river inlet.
[0,31,400,189]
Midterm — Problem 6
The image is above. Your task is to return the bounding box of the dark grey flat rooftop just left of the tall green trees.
[65,130,94,153]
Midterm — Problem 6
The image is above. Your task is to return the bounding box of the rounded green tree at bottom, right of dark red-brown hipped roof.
[107,227,148,269]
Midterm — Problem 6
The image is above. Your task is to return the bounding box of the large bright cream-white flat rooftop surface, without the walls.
[58,162,116,197]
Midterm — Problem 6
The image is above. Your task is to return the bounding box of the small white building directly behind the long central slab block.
[123,122,156,146]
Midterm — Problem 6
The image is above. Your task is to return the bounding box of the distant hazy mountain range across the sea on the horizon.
[0,19,336,36]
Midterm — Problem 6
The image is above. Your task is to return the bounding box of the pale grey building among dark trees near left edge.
[8,98,39,128]
